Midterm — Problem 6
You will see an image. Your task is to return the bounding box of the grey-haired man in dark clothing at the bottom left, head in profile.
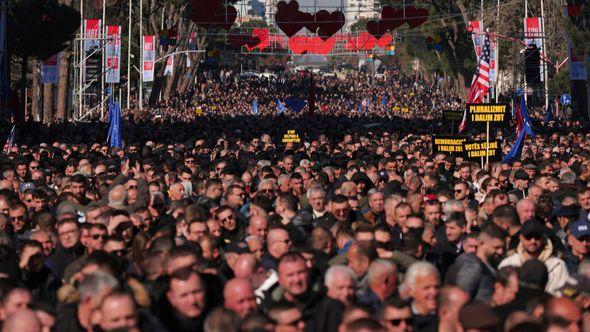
[55,271,119,331]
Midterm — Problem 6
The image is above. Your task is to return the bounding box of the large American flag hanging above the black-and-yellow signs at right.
[459,33,490,132]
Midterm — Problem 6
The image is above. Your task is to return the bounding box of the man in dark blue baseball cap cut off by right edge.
[563,220,590,274]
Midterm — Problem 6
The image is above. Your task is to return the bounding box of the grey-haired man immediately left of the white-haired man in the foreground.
[359,258,398,314]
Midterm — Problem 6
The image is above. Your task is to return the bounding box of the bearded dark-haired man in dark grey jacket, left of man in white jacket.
[446,225,505,301]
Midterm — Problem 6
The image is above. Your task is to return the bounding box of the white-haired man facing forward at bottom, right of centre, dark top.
[402,262,440,331]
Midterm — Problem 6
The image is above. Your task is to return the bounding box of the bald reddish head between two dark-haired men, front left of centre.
[223,278,257,319]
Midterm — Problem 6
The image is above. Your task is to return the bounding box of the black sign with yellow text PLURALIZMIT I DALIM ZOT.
[467,104,510,130]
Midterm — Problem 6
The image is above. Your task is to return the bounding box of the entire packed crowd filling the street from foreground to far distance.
[0,63,590,332]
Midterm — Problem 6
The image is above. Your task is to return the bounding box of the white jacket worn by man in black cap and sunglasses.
[498,240,569,295]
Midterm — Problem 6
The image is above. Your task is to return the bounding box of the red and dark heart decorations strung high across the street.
[190,0,429,54]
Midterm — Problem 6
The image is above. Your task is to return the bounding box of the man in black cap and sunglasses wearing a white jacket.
[498,219,569,294]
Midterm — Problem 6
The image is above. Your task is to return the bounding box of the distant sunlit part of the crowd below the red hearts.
[129,68,468,121]
